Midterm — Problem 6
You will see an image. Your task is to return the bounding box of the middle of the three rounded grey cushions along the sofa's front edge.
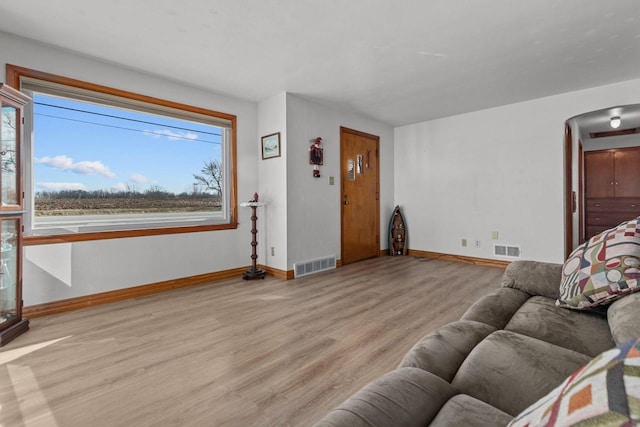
[400,320,496,382]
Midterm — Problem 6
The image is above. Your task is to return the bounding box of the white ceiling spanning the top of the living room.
[0,0,640,126]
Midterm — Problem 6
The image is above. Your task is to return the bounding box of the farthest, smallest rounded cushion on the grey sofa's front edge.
[462,288,531,329]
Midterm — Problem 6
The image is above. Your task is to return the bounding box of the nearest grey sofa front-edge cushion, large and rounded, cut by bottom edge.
[315,368,457,427]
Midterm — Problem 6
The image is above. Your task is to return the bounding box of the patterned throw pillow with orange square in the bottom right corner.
[508,338,640,427]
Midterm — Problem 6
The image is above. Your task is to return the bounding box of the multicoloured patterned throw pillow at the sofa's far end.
[556,217,640,309]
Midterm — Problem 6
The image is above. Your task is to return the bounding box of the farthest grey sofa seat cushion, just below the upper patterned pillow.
[504,294,616,357]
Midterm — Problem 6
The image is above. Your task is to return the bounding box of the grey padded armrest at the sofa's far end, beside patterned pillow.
[502,261,562,299]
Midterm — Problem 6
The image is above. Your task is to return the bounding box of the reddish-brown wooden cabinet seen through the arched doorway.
[584,147,640,239]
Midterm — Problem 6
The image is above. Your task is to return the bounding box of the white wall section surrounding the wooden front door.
[287,93,394,269]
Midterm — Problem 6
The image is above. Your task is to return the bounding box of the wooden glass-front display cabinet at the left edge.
[0,83,29,346]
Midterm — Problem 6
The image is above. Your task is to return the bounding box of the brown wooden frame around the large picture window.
[6,64,238,245]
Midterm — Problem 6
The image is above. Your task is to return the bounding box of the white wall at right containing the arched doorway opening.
[395,80,640,262]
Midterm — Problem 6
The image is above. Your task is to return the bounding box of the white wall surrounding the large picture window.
[0,33,259,305]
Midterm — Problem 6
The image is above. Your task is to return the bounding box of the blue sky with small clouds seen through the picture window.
[33,94,221,194]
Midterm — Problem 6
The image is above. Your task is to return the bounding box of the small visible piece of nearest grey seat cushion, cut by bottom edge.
[429,394,513,427]
